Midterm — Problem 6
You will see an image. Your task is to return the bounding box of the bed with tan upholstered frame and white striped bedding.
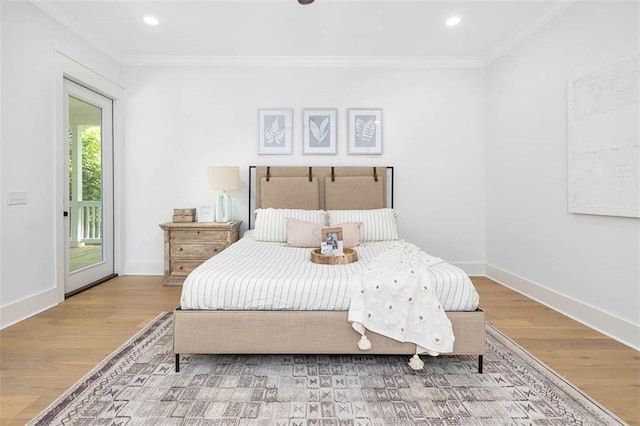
[173,166,485,373]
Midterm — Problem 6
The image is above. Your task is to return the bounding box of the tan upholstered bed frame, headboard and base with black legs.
[173,166,486,373]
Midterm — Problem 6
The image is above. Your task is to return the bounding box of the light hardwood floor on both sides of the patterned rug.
[0,276,640,425]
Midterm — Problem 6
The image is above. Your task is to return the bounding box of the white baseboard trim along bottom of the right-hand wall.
[485,264,640,350]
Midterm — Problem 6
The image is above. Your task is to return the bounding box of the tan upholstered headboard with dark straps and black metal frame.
[249,166,393,227]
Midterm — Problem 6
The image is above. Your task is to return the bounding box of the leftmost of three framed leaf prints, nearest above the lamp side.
[258,108,293,154]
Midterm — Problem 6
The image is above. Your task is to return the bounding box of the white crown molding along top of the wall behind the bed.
[122,55,484,68]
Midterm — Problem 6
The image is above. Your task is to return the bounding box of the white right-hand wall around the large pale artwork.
[486,2,640,347]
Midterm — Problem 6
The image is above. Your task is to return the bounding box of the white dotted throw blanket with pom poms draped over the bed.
[348,241,455,369]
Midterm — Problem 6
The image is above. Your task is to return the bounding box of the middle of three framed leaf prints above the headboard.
[302,108,338,154]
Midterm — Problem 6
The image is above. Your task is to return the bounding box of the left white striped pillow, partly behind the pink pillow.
[254,208,327,243]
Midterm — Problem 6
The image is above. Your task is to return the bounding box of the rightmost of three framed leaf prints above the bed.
[347,109,382,154]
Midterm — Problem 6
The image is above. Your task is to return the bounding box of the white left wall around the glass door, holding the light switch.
[0,1,121,327]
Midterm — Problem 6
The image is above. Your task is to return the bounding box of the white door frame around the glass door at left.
[52,51,124,303]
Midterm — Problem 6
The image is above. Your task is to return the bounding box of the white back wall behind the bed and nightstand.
[123,65,484,274]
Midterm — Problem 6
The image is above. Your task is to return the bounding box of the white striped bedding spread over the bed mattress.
[180,232,479,311]
